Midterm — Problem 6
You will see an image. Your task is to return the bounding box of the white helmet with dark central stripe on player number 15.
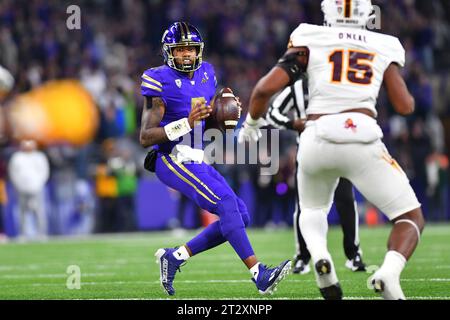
[322,0,375,28]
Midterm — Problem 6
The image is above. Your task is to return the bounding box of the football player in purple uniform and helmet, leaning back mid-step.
[140,22,291,295]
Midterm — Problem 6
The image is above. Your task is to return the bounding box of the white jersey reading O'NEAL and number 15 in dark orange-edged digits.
[289,23,405,115]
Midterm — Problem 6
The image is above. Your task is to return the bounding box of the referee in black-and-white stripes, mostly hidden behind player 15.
[266,76,366,274]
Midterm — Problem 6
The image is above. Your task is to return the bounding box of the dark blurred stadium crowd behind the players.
[0,0,450,239]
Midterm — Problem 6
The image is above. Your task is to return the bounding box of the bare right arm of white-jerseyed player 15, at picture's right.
[383,63,415,115]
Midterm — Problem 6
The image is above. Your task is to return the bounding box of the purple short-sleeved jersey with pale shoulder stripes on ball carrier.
[141,61,217,153]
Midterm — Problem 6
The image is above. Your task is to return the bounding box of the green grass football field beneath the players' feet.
[0,225,450,300]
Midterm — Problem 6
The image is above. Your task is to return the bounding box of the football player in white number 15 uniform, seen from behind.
[239,0,425,300]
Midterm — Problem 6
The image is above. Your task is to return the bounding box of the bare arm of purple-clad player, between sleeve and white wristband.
[139,97,169,148]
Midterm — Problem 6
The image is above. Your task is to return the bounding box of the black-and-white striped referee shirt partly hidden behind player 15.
[266,77,308,129]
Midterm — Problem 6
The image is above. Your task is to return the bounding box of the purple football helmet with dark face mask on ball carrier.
[161,22,204,72]
